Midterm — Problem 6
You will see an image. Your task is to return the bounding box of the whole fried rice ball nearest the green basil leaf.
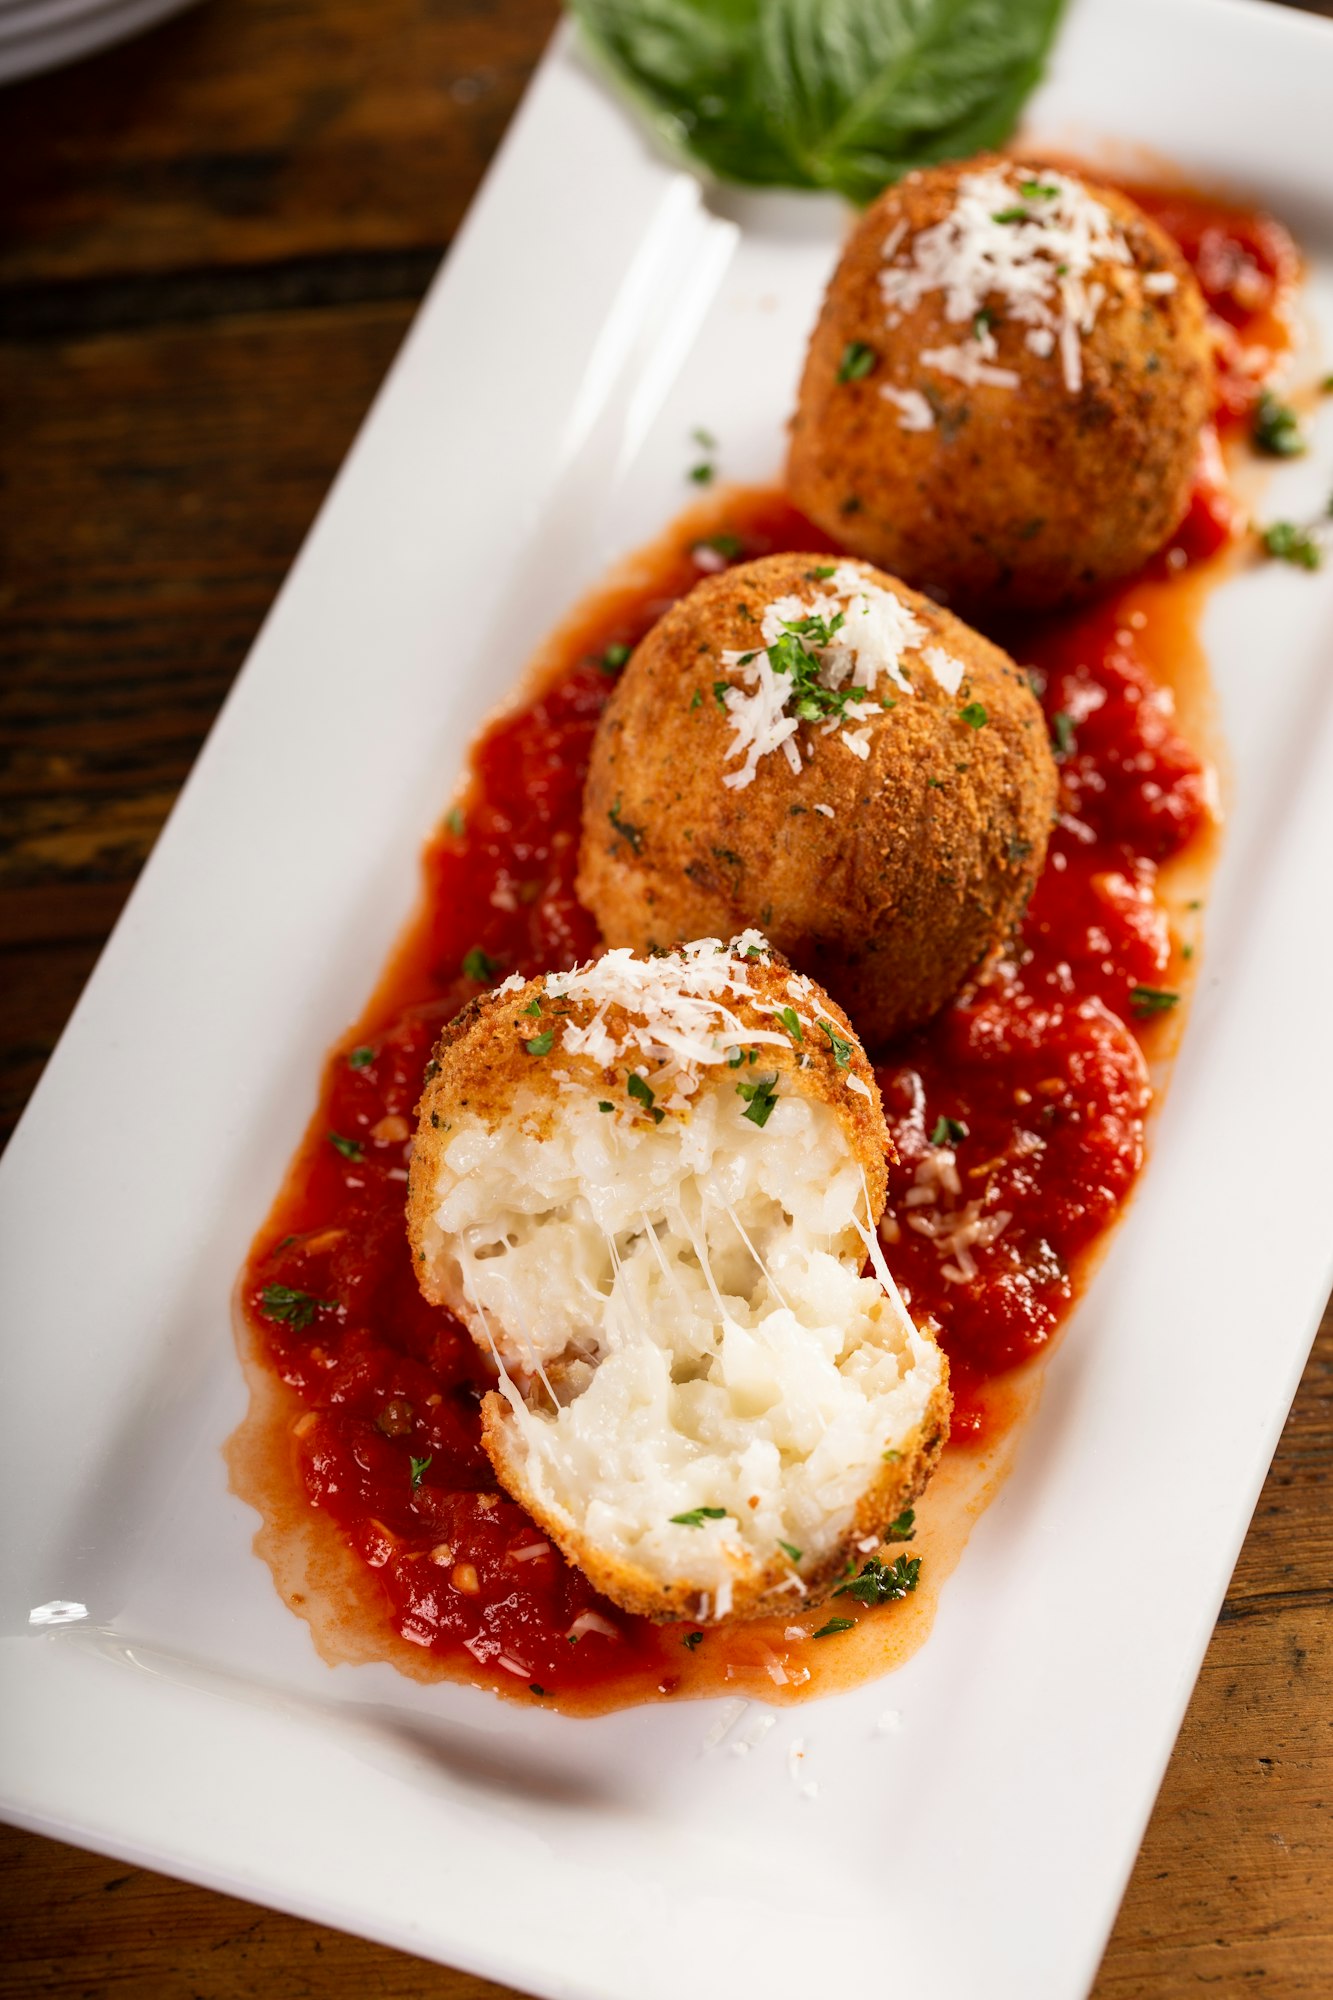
[787,156,1213,608]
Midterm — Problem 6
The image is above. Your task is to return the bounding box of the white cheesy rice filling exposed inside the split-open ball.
[426,1076,941,1616]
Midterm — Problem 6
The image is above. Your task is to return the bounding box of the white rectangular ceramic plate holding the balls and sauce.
[0,0,1333,2000]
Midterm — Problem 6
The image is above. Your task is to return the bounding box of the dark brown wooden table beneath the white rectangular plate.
[0,0,1333,2000]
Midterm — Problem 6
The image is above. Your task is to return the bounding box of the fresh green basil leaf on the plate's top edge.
[568,0,1063,202]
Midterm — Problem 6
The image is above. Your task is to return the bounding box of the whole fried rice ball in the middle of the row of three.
[578,556,1057,1046]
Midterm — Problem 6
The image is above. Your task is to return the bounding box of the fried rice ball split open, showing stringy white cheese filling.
[408,930,951,1622]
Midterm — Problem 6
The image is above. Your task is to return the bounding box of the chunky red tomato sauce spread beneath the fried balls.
[232,188,1299,1710]
